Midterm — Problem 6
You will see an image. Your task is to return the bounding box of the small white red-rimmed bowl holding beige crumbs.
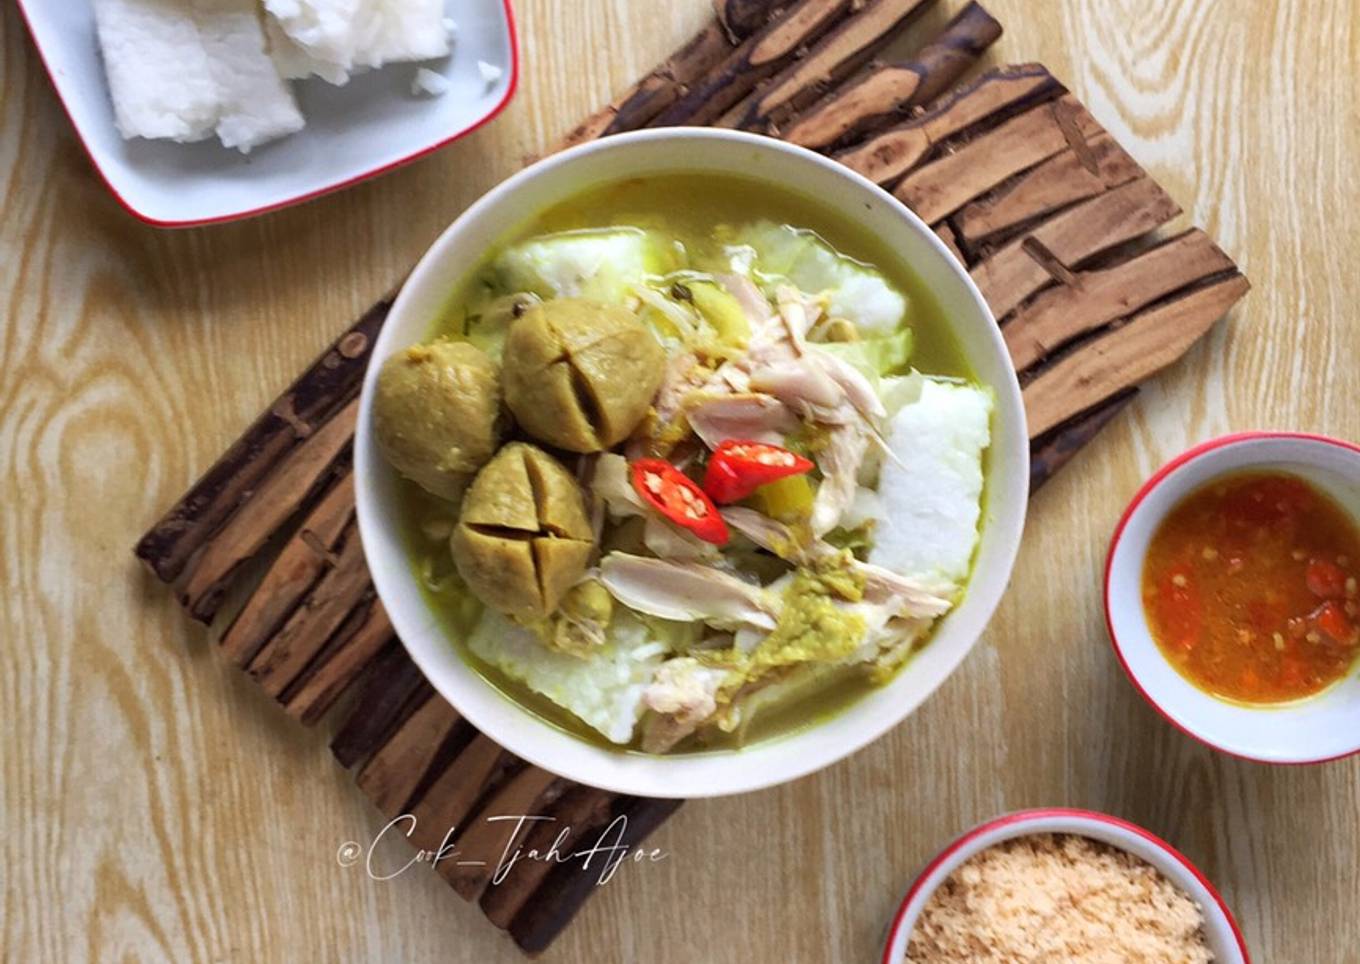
[883,808,1251,964]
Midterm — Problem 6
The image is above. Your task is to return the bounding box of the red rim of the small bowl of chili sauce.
[1102,430,1360,767]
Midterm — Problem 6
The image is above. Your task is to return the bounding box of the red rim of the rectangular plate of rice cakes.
[16,0,522,230]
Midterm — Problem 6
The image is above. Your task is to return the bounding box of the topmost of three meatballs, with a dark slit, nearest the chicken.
[502,298,665,453]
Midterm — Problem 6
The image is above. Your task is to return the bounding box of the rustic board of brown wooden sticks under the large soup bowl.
[136,0,1248,953]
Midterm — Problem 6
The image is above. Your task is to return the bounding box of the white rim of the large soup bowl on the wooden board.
[355,128,1030,799]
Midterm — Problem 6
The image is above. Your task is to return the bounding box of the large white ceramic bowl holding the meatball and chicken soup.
[355,129,1028,797]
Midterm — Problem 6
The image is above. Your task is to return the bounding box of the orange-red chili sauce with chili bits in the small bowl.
[1142,472,1360,704]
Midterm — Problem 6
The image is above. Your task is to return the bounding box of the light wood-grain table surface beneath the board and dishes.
[0,0,1360,964]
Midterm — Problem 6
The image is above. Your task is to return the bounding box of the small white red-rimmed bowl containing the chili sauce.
[1104,432,1360,764]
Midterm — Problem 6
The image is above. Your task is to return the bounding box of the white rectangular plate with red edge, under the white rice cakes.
[19,0,520,227]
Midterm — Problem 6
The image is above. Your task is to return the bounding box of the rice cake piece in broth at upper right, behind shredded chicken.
[725,220,907,336]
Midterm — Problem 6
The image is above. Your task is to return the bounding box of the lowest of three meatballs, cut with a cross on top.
[450,442,594,624]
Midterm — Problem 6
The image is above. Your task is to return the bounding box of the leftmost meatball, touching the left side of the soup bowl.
[373,341,500,502]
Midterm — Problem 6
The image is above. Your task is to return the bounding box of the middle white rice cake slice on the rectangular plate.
[190,0,306,154]
